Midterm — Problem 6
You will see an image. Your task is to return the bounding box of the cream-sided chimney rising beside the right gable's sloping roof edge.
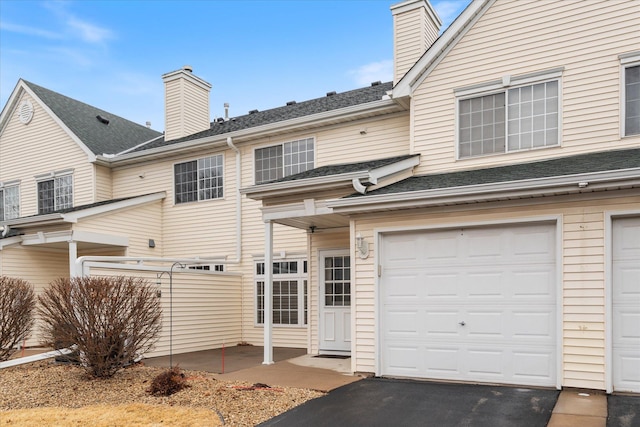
[391,0,442,84]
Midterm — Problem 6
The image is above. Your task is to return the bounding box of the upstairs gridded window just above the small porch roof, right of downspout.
[255,138,315,184]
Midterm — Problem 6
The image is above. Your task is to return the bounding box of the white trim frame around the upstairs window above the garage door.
[453,67,564,161]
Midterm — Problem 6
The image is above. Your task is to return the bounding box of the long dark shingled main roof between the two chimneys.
[132,82,393,152]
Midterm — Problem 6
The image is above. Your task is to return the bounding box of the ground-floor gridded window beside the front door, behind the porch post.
[256,261,308,326]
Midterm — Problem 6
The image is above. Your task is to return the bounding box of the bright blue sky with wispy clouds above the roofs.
[0,0,469,130]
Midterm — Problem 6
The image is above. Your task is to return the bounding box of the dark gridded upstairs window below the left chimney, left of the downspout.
[173,154,224,204]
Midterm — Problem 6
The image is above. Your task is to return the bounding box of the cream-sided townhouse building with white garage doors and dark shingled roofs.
[0,0,640,393]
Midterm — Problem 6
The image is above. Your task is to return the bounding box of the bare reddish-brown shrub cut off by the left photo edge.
[0,276,36,361]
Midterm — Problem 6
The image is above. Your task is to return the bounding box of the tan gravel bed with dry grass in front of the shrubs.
[0,361,322,427]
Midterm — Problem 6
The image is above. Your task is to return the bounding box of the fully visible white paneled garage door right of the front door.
[380,224,557,386]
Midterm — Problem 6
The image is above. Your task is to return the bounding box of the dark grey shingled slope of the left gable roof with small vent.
[23,80,162,155]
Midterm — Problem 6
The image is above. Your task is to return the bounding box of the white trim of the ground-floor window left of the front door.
[252,256,311,329]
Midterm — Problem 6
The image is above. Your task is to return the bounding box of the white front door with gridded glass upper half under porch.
[319,250,351,354]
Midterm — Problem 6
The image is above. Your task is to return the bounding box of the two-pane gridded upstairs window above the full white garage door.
[458,80,559,158]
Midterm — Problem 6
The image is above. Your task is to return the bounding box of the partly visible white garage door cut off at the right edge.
[612,218,640,393]
